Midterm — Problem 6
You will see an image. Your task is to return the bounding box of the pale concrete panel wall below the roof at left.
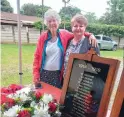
[1,25,40,43]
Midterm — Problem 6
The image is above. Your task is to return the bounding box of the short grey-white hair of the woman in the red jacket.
[44,9,61,25]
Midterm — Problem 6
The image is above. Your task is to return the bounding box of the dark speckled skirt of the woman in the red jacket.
[40,69,62,88]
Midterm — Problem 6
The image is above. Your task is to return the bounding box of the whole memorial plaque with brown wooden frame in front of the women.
[60,49,119,117]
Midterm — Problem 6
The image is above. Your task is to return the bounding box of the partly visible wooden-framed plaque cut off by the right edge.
[110,69,124,117]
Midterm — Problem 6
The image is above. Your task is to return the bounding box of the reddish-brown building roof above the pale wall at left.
[0,12,41,25]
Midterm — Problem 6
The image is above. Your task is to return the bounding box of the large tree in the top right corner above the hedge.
[100,0,124,25]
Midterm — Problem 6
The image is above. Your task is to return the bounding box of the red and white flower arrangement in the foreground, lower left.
[1,87,61,117]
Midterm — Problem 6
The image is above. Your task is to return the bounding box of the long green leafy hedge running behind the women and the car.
[34,21,124,39]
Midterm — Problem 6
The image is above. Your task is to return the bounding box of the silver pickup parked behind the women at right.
[95,35,117,51]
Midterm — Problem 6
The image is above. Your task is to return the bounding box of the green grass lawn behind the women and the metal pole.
[1,44,123,86]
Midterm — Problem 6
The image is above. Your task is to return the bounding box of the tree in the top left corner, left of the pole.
[1,0,13,13]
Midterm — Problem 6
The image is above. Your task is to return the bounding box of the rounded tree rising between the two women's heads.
[59,6,81,21]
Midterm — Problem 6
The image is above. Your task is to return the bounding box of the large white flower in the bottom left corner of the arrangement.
[3,105,21,117]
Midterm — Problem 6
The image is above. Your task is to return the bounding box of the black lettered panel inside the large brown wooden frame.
[64,59,109,117]
